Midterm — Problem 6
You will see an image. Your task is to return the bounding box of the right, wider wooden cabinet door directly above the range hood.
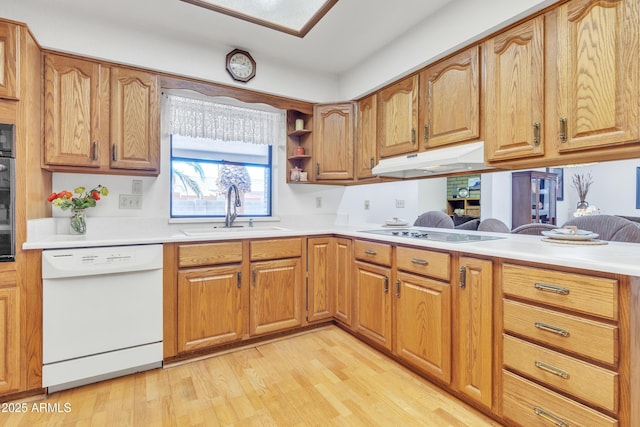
[419,46,480,148]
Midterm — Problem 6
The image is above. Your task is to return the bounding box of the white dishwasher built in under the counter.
[42,245,162,392]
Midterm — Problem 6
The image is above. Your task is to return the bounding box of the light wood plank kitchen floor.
[5,327,500,427]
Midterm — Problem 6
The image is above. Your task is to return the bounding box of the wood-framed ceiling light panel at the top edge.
[181,0,338,37]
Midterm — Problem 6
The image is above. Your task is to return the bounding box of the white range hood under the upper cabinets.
[372,141,493,178]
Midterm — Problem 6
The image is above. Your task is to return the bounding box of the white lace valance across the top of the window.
[167,95,285,146]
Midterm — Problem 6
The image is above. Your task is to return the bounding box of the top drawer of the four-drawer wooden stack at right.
[502,264,618,320]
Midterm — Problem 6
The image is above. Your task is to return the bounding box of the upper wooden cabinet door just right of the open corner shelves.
[313,102,354,181]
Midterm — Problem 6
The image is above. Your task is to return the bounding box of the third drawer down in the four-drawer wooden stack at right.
[503,335,618,412]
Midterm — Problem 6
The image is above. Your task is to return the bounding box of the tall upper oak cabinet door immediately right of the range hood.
[483,16,545,160]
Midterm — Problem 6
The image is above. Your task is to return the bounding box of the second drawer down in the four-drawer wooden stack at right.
[503,300,618,365]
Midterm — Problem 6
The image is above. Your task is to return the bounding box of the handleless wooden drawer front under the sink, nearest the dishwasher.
[178,242,242,267]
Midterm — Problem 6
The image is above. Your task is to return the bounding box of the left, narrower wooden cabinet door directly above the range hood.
[377,75,419,157]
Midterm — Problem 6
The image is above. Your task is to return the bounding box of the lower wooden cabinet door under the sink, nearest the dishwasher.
[178,264,246,352]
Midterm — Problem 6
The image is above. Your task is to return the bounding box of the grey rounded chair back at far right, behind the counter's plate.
[563,215,640,243]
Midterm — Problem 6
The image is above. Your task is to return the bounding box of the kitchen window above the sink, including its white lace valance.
[168,95,285,218]
